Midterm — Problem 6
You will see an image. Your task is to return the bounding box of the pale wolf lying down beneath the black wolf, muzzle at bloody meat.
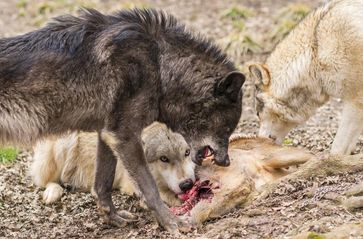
[30,122,195,205]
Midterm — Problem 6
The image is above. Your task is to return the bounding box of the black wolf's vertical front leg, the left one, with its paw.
[93,134,137,227]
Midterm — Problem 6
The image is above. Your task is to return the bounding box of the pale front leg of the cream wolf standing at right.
[331,103,363,155]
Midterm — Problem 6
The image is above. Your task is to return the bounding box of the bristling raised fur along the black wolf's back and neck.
[0,8,226,64]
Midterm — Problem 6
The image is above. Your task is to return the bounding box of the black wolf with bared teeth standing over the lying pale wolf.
[0,9,245,232]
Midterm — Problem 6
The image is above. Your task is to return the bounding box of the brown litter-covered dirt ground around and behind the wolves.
[0,0,363,238]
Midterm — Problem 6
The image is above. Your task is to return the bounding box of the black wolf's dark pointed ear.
[215,71,246,102]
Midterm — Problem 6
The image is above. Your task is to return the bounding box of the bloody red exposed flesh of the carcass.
[170,180,218,216]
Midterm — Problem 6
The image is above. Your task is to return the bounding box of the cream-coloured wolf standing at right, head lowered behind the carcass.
[249,0,363,155]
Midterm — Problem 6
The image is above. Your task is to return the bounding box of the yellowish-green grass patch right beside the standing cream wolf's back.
[270,3,311,43]
